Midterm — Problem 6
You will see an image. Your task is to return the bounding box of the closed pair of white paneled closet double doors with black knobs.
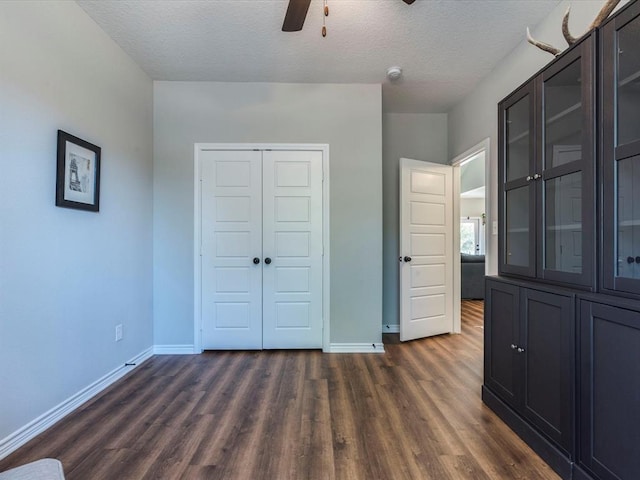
[200,150,323,350]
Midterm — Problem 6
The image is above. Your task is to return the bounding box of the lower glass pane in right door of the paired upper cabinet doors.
[544,172,582,274]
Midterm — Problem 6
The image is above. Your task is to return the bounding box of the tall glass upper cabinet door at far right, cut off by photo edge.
[602,2,640,295]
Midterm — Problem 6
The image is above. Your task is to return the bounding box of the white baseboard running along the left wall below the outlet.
[0,348,153,459]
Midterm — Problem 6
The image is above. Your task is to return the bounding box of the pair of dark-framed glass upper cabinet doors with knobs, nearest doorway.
[498,32,596,287]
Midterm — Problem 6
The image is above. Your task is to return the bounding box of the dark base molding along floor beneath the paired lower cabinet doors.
[482,385,572,480]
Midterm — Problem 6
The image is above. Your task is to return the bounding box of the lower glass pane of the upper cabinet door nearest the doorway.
[505,185,530,267]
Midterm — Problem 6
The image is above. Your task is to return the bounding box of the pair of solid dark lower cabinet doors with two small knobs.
[485,278,575,456]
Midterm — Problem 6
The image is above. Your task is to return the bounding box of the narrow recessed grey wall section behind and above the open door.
[382,113,449,325]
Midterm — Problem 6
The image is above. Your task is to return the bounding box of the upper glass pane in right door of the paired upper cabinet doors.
[543,59,583,169]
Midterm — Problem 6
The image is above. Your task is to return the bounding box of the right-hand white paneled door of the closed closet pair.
[263,151,322,348]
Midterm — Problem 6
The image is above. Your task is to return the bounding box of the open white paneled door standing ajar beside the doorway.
[400,158,458,341]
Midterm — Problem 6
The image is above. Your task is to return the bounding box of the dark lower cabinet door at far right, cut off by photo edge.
[579,298,640,480]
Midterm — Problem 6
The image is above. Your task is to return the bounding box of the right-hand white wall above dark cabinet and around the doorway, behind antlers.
[449,0,626,274]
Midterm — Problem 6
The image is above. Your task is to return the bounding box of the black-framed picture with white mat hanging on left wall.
[56,130,100,212]
